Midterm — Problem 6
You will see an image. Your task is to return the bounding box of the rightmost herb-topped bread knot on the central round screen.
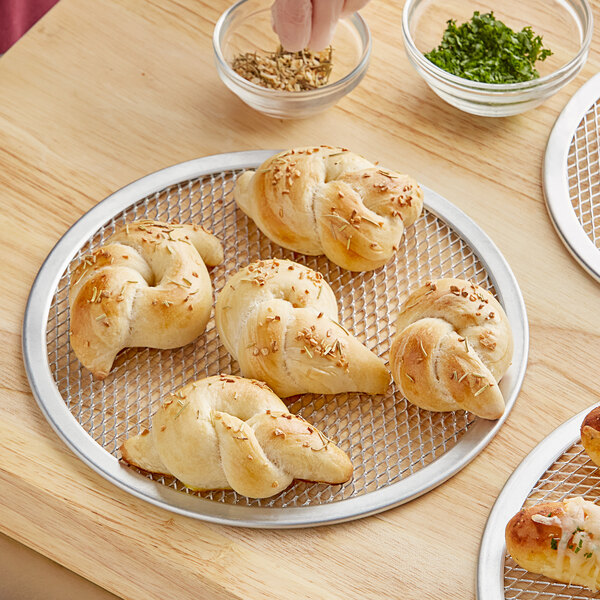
[390,279,513,419]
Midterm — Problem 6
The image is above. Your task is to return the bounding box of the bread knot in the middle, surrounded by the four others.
[215,260,390,398]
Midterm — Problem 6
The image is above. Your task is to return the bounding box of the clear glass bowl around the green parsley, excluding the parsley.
[402,0,593,117]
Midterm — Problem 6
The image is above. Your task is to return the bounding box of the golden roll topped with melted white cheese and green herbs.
[506,496,600,590]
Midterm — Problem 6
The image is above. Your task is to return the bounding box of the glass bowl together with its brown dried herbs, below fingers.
[213,0,371,119]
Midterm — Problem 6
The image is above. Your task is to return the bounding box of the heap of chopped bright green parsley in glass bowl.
[425,11,552,83]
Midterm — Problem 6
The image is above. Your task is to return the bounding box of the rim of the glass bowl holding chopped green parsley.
[402,0,594,94]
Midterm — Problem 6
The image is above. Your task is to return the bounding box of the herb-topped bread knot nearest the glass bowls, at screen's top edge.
[233,146,423,271]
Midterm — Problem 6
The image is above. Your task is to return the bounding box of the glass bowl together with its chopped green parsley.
[402,0,593,116]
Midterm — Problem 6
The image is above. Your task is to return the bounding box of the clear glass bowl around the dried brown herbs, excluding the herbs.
[213,0,371,119]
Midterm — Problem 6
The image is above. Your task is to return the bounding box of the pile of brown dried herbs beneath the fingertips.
[231,46,333,92]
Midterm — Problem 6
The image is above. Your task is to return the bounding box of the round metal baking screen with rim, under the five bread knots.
[24,152,528,527]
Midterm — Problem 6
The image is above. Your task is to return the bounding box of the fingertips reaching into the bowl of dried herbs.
[271,0,369,52]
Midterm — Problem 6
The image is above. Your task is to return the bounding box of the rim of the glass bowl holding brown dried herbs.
[212,0,372,100]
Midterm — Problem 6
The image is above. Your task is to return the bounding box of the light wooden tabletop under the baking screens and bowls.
[0,0,600,599]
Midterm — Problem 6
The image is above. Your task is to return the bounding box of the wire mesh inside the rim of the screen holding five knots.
[47,171,494,507]
